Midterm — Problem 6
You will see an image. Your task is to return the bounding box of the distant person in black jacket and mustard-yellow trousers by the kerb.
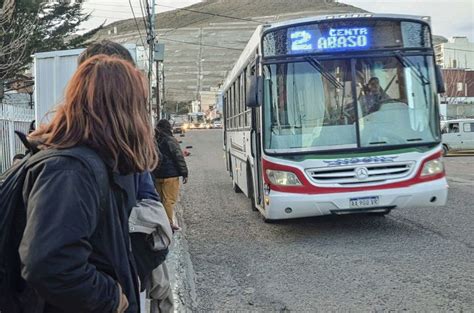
[153,119,188,230]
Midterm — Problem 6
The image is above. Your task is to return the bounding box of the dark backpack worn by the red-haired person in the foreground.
[0,146,109,313]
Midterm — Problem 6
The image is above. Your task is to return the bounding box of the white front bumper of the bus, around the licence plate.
[264,178,448,220]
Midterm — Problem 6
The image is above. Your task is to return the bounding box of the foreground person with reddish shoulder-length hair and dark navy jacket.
[19,55,157,313]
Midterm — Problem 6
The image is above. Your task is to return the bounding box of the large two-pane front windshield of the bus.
[263,53,440,153]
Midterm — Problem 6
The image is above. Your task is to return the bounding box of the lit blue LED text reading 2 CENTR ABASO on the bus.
[289,27,370,53]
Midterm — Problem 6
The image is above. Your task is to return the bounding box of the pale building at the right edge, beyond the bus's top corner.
[435,36,474,69]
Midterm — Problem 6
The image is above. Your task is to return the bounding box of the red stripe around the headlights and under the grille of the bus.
[262,152,446,194]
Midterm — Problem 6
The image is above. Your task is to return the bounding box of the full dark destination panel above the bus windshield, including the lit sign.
[263,18,431,57]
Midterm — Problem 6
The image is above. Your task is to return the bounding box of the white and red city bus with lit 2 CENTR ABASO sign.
[222,13,448,221]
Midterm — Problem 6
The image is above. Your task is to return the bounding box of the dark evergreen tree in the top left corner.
[0,0,102,94]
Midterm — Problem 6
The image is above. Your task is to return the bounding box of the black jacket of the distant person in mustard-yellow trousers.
[153,133,188,178]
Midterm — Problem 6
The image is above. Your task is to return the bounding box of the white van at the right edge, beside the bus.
[441,119,474,155]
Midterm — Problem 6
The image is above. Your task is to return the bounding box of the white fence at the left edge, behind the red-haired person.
[0,104,35,173]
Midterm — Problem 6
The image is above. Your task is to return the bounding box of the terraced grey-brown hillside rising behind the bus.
[96,0,363,110]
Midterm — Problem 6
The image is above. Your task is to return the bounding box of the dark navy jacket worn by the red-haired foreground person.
[20,156,139,313]
